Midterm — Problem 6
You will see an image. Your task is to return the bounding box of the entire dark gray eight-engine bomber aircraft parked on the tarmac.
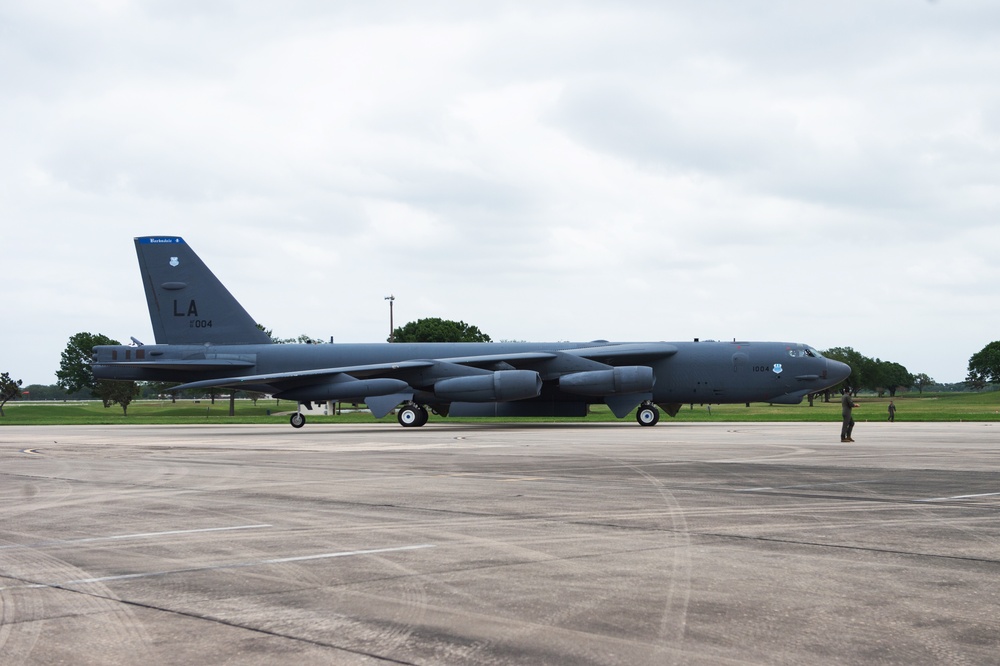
[93,236,851,428]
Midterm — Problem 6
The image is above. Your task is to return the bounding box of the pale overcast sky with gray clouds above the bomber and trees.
[0,0,1000,384]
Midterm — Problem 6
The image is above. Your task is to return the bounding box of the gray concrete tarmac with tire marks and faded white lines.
[0,419,1000,666]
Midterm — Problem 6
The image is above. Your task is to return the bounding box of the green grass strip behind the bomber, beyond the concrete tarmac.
[0,391,1000,426]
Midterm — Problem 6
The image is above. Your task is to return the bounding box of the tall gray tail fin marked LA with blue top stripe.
[135,236,271,345]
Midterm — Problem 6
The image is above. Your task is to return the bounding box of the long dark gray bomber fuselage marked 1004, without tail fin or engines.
[93,341,846,412]
